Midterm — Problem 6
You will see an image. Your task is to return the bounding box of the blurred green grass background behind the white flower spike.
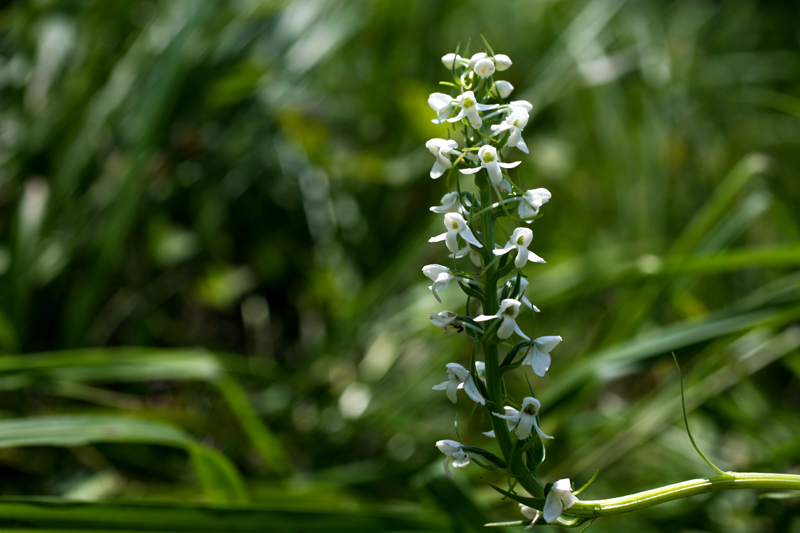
[0,0,800,532]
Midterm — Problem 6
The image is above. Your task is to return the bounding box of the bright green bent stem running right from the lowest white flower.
[564,472,800,518]
